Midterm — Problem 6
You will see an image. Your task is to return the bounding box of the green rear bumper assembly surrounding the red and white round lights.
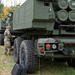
[36,38,75,59]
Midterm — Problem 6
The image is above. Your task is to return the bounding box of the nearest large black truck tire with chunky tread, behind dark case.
[19,40,37,73]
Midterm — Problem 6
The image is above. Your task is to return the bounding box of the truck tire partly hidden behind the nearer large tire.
[14,37,23,63]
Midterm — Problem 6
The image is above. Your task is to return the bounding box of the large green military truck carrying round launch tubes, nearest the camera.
[0,0,75,73]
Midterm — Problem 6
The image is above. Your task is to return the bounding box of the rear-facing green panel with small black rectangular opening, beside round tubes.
[34,0,55,20]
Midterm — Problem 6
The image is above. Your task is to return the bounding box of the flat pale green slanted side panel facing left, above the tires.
[13,0,34,30]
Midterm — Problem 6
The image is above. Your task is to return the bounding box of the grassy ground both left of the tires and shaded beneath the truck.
[0,46,75,75]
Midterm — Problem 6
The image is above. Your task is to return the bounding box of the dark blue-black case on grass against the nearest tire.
[11,64,26,75]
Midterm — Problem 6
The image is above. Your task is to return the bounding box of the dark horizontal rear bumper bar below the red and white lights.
[35,52,75,59]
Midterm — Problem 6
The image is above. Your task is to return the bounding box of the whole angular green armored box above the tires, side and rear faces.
[13,0,55,30]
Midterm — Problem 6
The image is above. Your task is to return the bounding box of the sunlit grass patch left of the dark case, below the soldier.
[0,46,15,75]
